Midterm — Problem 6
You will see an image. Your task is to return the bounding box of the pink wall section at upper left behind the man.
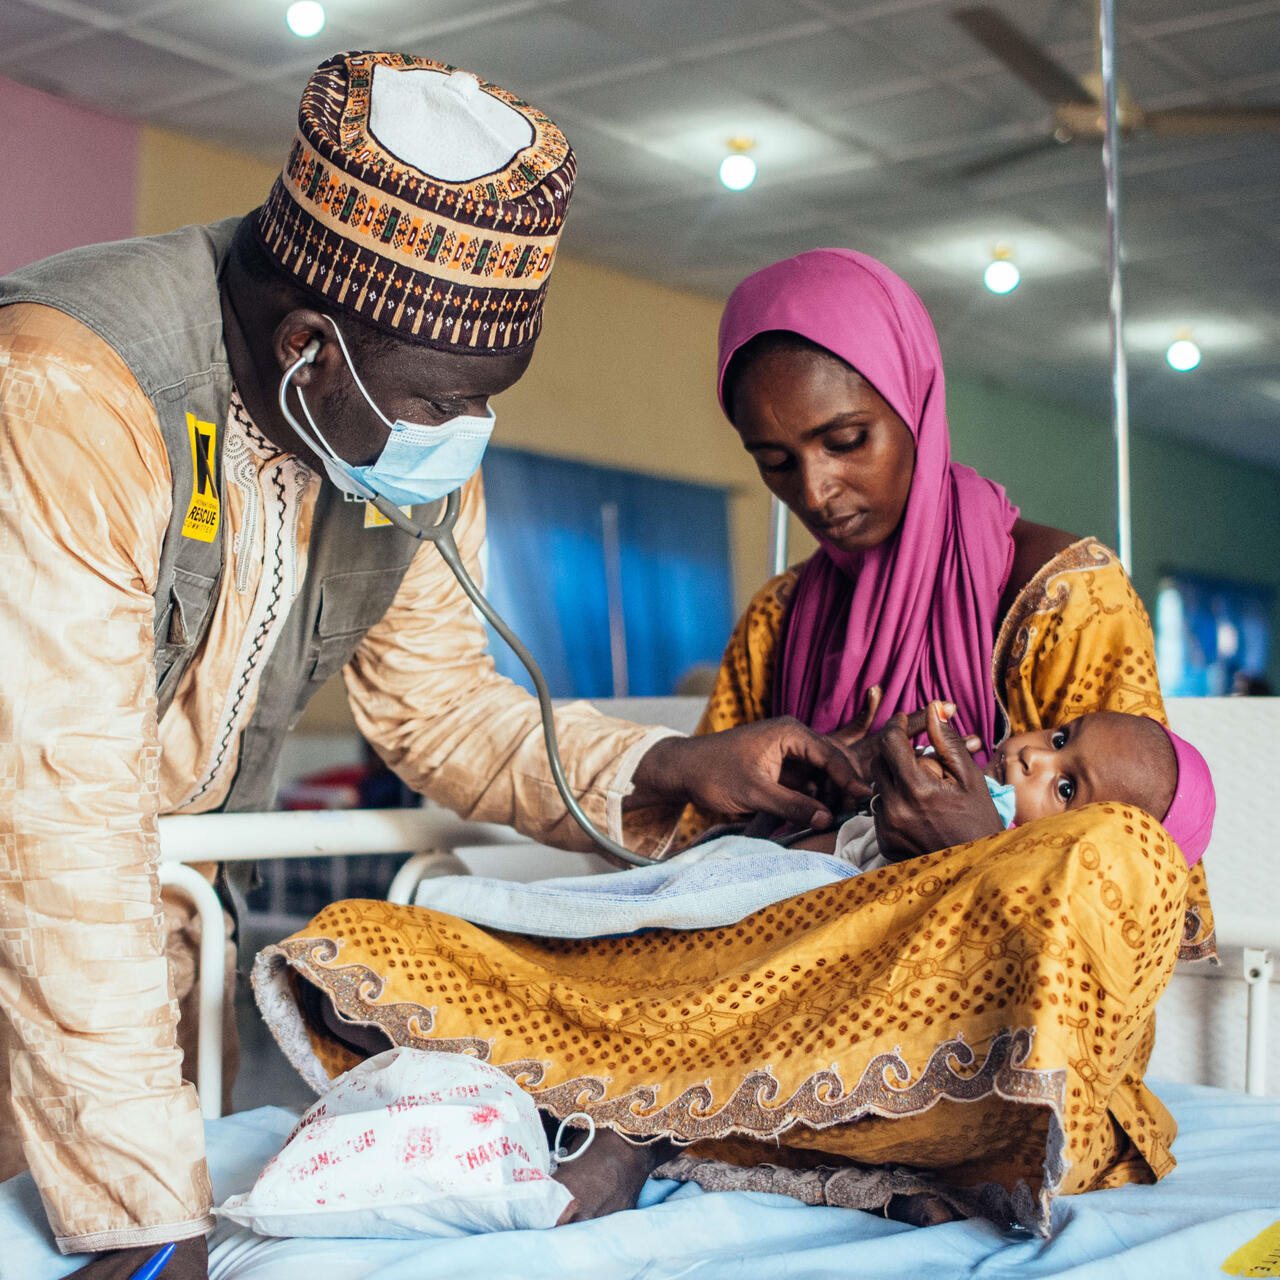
[0,78,140,274]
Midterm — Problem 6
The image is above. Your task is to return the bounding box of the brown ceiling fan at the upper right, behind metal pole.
[952,5,1280,178]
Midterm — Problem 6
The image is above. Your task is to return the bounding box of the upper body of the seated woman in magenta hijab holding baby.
[686,248,1198,852]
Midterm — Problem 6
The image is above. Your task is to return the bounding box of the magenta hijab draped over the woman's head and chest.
[719,248,1018,759]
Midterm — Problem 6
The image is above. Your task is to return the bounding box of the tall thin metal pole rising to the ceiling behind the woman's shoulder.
[1098,0,1133,573]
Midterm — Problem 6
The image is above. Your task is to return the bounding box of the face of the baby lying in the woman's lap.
[986,712,1176,823]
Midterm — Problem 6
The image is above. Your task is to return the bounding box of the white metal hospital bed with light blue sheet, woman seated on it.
[0,699,1280,1280]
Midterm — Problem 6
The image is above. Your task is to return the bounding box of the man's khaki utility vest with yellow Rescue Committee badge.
[0,218,438,813]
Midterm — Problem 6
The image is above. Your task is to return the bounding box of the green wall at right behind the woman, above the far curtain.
[947,378,1280,689]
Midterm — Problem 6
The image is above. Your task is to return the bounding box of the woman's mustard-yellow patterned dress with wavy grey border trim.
[259,541,1212,1231]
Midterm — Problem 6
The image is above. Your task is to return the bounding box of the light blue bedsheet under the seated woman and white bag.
[0,1083,1280,1280]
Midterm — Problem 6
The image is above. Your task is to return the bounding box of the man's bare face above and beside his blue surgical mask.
[294,321,532,466]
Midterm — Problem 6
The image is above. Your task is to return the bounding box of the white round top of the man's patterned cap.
[369,64,534,182]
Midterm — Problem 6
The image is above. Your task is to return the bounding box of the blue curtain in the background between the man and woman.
[484,448,733,698]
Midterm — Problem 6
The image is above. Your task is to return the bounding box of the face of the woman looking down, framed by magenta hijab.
[732,348,915,552]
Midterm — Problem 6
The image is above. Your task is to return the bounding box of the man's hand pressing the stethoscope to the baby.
[623,717,855,829]
